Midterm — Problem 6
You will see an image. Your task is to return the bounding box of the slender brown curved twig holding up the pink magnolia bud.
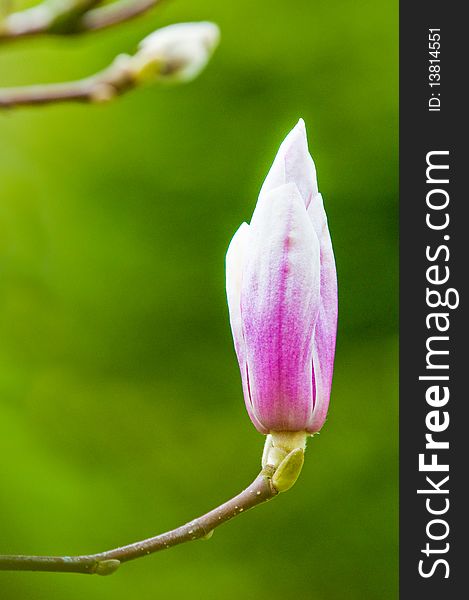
[0,466,278,575]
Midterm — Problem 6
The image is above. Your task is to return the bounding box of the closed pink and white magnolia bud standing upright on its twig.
[226,119,337,434]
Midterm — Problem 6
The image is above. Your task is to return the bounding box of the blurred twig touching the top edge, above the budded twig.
[0,0,163,42]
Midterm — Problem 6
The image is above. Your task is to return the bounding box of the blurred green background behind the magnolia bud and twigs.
[0,0,398,600]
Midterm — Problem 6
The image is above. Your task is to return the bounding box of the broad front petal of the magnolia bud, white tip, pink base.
[241,183,320,431]
